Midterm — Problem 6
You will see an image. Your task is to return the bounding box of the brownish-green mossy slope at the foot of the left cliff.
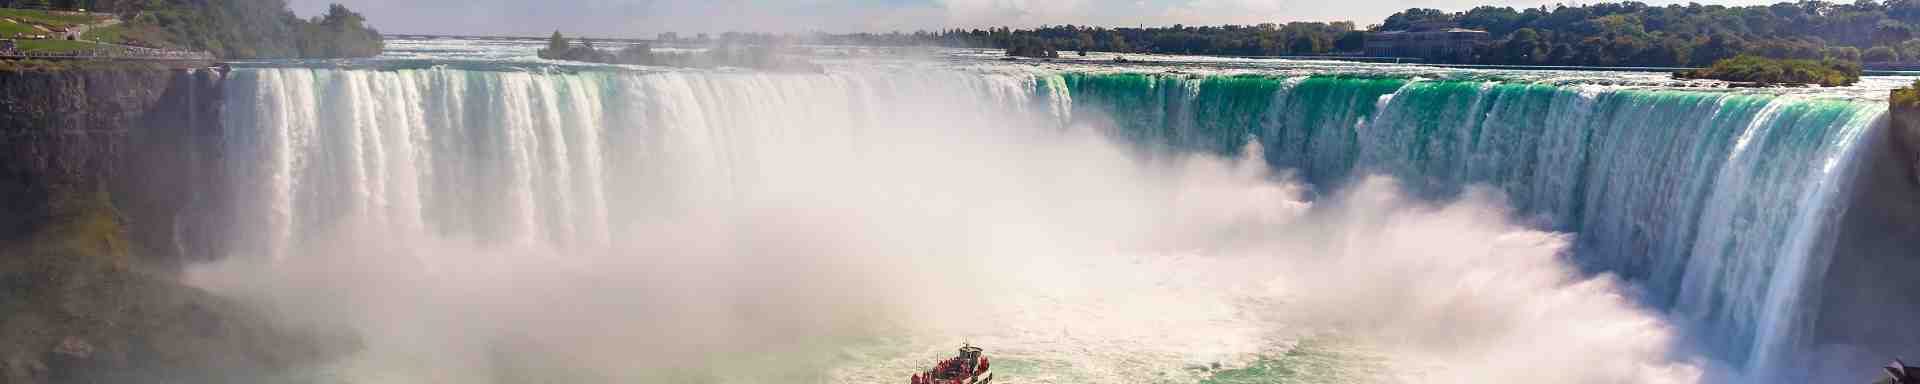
[0,184,342,384]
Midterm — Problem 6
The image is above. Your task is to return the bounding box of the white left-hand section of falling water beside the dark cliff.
[227,67,1039,255]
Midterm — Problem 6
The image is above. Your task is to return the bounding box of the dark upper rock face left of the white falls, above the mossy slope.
[0,67,225,267]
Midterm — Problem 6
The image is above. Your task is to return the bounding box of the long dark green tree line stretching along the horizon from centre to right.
[828,0,1920,67]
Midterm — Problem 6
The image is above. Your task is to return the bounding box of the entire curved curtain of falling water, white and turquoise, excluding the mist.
[227,67,1884,374]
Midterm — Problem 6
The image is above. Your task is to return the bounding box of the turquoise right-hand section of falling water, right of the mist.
[1043,73,1885,372]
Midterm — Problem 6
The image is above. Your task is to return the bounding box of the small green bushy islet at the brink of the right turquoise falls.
[1674,56,1860,86]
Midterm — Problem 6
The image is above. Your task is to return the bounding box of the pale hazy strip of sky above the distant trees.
[290,0,1770,36]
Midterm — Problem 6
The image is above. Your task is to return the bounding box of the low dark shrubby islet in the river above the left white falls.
[538,31,822,71]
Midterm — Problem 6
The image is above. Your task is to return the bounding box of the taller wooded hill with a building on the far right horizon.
[1379,0,1920,67]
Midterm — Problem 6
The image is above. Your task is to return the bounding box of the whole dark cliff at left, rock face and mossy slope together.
[0,65,341,384]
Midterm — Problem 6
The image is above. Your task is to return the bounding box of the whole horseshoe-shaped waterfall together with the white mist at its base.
[194,53,1920,382]
